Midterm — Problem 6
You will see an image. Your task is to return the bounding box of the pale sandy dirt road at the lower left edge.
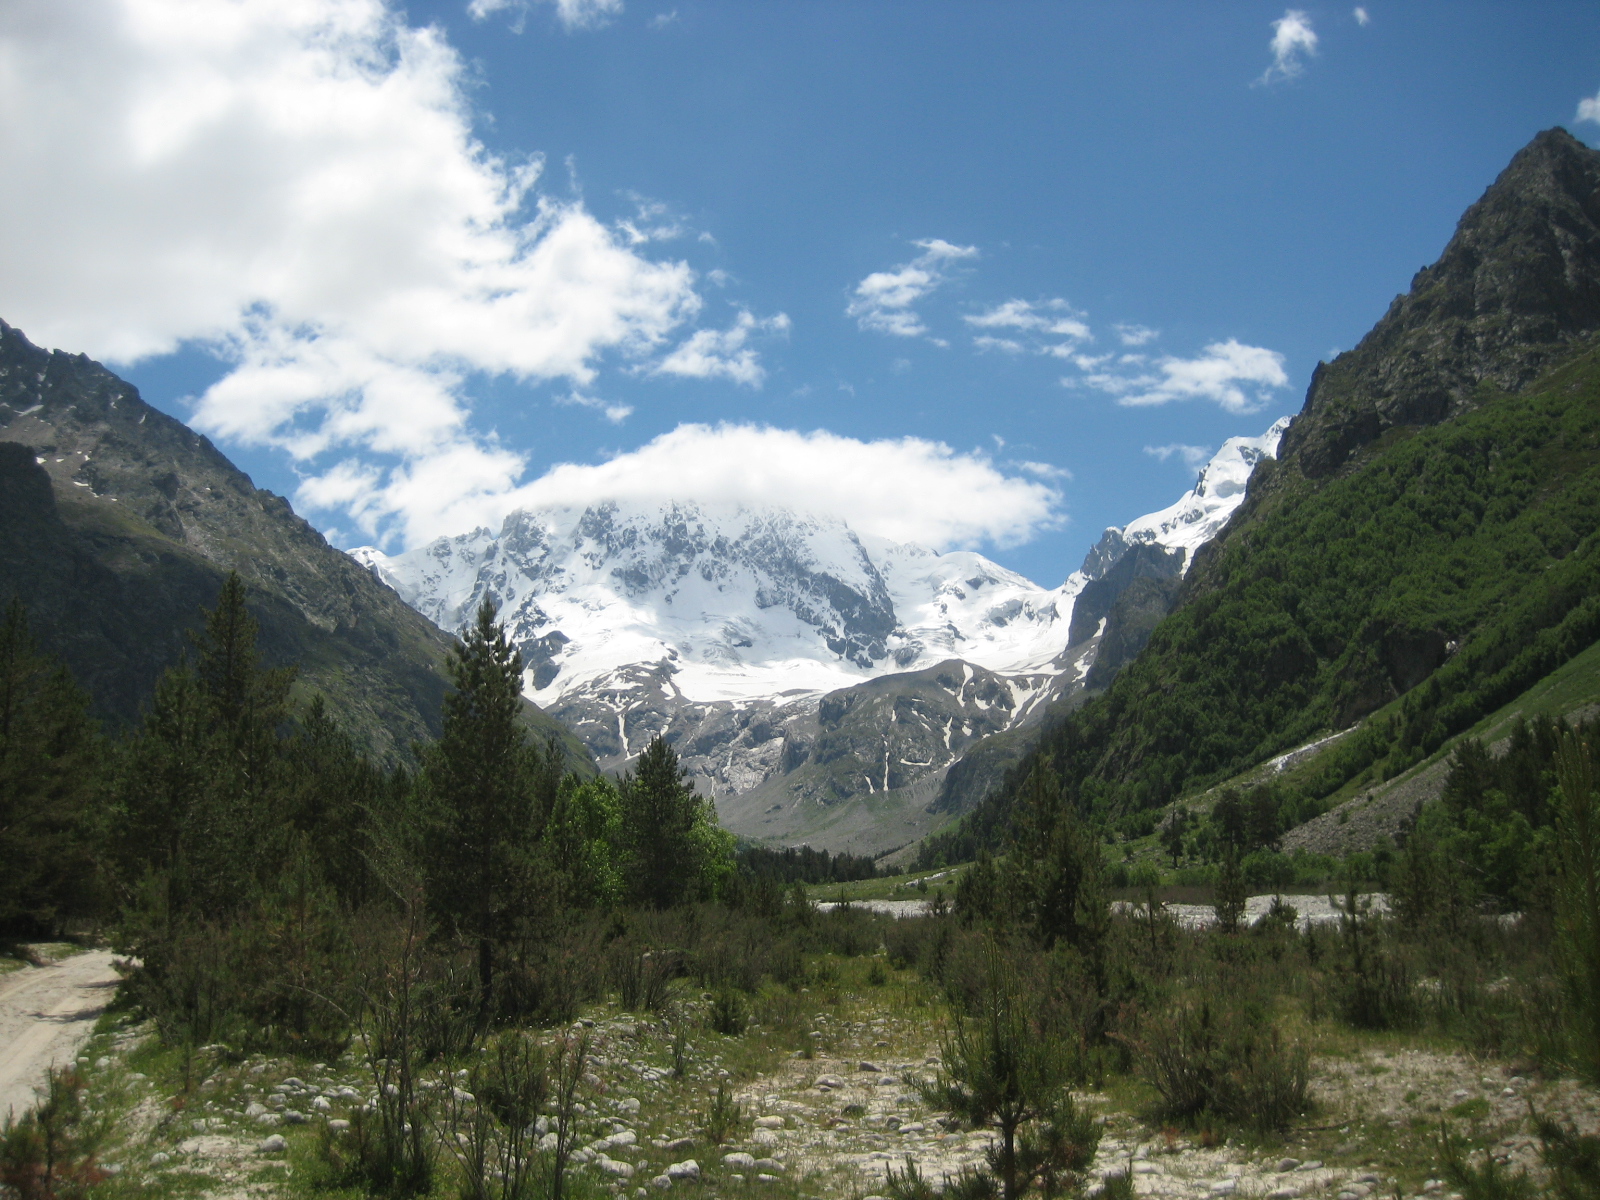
[0,950,118,1118]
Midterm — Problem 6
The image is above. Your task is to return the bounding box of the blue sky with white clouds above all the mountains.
[0,0,1600,584]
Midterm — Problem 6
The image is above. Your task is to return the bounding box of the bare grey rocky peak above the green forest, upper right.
[1278,130,1600,478]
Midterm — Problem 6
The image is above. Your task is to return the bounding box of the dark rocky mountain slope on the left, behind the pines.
[0,322,592,770]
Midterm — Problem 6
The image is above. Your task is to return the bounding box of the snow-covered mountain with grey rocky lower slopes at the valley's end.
[352,421,1286,851]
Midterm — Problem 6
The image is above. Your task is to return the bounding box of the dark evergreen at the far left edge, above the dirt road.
[0,600,102,934]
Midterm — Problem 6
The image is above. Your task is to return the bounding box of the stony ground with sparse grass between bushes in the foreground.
[15,960,1600,1200]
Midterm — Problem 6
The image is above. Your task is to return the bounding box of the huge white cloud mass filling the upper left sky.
[0,0,720,539]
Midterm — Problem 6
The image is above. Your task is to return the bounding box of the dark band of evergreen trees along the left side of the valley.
[0,574,734,1040]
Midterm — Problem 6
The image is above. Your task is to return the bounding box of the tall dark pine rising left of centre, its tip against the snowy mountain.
[421,598,539,1021]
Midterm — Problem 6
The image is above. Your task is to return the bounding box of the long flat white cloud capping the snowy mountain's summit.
[492,424,1061,549]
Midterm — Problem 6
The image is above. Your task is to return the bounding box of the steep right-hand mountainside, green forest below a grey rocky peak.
[930,131,1600,858]
